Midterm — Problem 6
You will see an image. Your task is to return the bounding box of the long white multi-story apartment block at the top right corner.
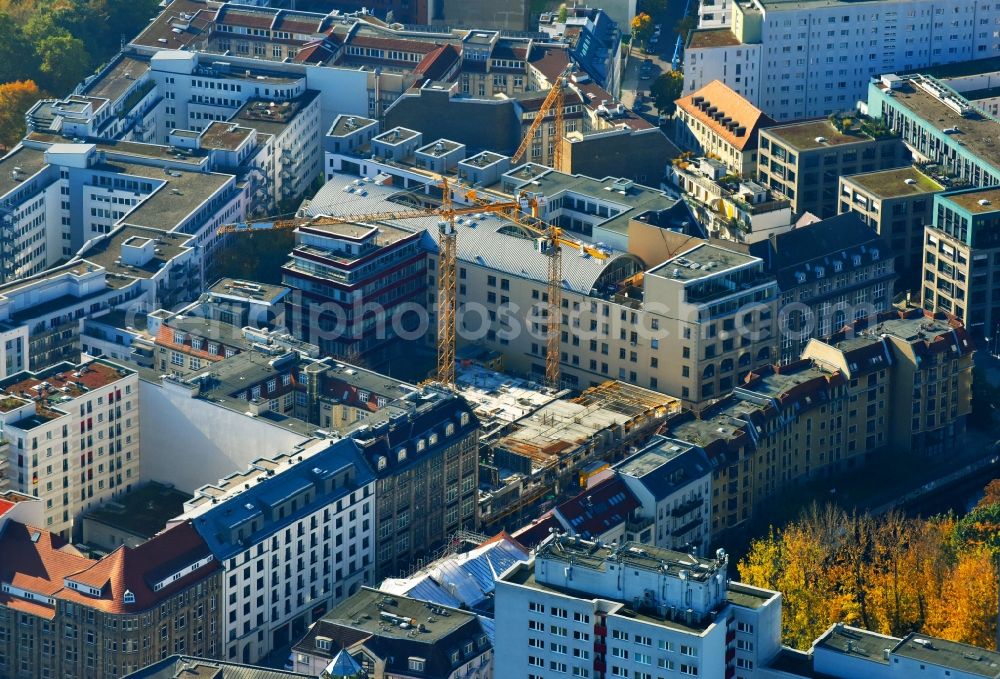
[684,0,1000,120]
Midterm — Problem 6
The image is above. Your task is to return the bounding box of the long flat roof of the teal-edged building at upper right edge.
[880,80,1000,172]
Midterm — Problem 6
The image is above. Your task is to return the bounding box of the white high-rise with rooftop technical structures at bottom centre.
[494,534,781,679]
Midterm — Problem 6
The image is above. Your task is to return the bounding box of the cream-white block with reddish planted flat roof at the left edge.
[0,360,139,539]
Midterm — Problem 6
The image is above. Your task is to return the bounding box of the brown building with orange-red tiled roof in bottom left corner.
[0,522,222,679]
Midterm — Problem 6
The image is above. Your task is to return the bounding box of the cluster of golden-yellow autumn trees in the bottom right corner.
[738,502,1000,649]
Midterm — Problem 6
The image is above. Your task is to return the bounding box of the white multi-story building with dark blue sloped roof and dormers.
[168,439,375,663]
